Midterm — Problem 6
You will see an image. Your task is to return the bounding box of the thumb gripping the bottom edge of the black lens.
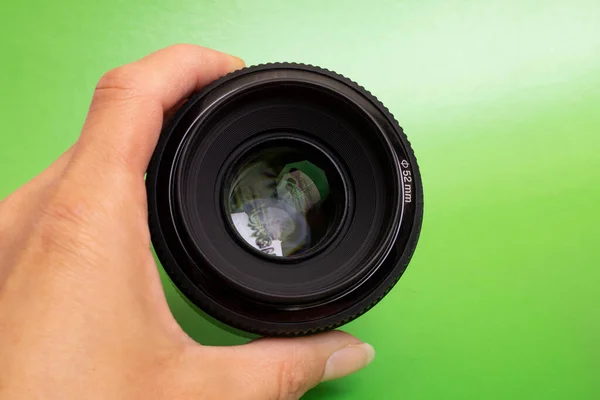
[205,331,375,400]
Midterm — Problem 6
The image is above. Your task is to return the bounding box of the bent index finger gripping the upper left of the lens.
[71,45,244,180]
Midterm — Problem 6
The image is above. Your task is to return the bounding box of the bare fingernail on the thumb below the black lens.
[321,343,375,382]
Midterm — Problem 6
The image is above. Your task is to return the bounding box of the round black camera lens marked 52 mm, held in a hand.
[146,64,423,336]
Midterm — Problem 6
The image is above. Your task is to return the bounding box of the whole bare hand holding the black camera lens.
[0,45,374,400]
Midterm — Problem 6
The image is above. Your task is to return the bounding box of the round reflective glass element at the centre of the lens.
[224,142,344,257]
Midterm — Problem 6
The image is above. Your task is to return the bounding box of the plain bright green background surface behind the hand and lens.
[0,0,600,400]
